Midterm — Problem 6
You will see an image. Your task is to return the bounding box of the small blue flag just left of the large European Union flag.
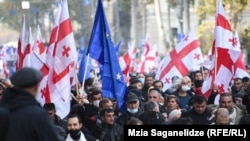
[78,49,92,83]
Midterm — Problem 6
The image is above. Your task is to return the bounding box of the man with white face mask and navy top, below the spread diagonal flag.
[173,76,194,110]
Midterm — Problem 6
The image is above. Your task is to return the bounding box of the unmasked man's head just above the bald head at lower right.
[219,93,233,112]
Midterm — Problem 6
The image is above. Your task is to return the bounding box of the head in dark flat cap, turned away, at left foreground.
[10,67,43,97]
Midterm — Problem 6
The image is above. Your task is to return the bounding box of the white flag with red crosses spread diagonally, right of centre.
[156,30,203,91]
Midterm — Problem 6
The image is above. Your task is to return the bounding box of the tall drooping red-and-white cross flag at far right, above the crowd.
[202,0,240,97]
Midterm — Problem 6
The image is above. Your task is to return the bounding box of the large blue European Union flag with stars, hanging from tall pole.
[87,0,127,112]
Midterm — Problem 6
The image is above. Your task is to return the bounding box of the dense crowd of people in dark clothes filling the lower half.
[0,68,250,141]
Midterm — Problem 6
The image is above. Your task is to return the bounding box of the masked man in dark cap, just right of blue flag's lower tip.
[117,92,142,126]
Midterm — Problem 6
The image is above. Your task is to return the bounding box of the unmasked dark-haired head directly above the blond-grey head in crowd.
[165,95,180,110]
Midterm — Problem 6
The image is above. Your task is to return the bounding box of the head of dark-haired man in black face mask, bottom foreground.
[67,114,82,140]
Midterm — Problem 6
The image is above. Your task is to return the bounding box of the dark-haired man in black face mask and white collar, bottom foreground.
[65,114,95,141]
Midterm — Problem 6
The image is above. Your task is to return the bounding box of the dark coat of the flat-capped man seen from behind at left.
[2,88,60,141]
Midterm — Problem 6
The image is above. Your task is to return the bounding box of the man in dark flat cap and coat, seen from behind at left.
[2,67,62,141]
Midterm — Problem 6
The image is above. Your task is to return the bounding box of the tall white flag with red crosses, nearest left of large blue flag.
[53,0,78,116]
